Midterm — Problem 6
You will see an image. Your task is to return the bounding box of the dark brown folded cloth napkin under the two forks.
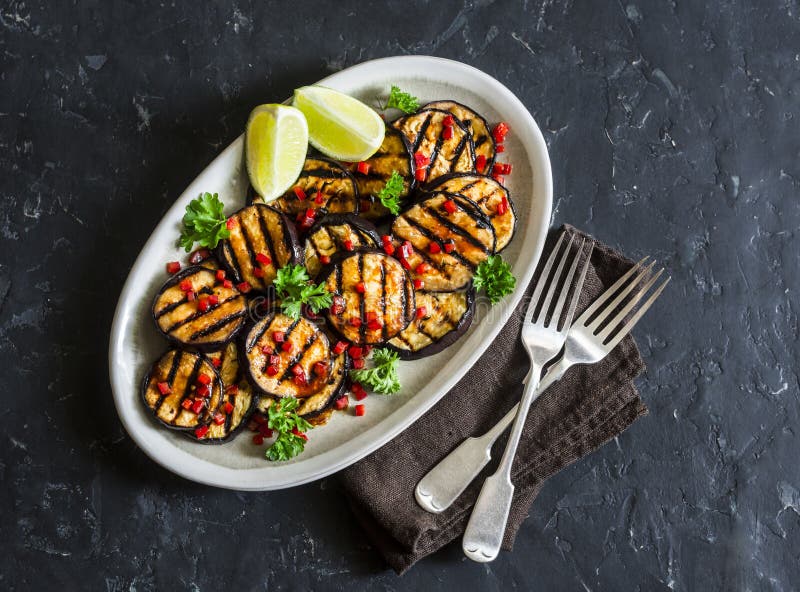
[340,226,647,574]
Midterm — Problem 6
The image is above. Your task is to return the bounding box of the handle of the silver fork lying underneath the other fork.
[414,356,572,514]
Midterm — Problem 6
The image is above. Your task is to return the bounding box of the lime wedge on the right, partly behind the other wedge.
[293,86,386,162]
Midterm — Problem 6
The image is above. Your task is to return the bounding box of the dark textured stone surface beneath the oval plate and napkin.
[0,0,800,591]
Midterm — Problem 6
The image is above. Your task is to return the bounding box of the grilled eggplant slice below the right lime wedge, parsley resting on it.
[347,127,415,220]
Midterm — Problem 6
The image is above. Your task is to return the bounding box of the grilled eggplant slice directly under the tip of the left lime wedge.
[251,156,359,218]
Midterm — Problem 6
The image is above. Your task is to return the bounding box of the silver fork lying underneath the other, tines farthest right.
[415,257,670,524]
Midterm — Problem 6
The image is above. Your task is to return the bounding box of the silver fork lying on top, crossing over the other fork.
[462,234,591,561]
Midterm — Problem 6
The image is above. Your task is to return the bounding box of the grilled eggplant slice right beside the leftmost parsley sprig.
[217,204,303,292]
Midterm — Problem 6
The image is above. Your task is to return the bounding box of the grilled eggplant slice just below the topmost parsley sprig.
[392,109,475,182]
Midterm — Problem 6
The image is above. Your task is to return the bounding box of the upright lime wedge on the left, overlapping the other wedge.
[244,105,308,202]
